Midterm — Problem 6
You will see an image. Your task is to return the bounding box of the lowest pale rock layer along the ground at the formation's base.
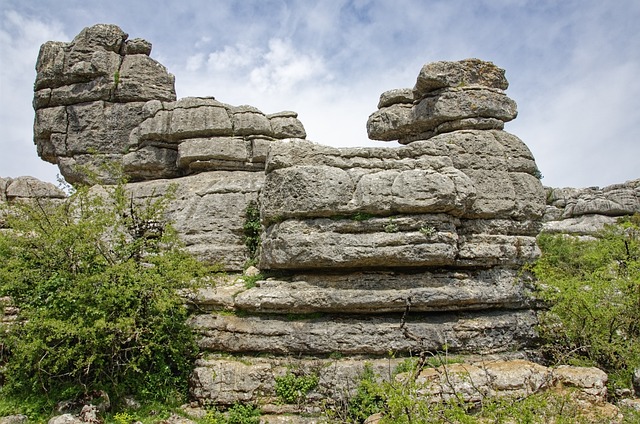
[192,357,607,412]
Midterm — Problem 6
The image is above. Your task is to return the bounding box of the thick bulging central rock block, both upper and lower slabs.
[260,130,544,269]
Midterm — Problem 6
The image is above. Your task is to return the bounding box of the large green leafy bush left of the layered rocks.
[0,178,215,408]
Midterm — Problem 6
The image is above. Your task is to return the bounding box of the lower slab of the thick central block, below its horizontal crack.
[260,215,539,269]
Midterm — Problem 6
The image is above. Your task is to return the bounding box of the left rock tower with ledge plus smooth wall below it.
[33,25,306,270]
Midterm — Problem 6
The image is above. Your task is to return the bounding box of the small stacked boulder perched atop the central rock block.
[367,59,517,144]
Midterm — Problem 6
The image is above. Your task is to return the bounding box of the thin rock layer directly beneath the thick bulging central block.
[230,269,530,314]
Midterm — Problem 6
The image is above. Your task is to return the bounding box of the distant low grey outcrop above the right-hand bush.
[543,179,640,236]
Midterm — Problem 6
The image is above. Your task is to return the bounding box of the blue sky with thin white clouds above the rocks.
[0,0,640,187]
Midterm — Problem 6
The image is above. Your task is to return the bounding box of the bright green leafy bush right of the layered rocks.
[533,216,640,393]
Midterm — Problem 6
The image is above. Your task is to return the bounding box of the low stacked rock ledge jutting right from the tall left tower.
[123,97,306,180]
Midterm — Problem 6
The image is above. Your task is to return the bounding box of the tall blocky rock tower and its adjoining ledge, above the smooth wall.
[33,25,306,184]
